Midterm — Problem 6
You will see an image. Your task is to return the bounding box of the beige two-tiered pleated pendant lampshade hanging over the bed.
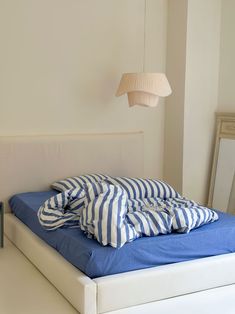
[116,72,171,107]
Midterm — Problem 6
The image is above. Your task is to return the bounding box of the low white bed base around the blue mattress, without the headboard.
[5,214,235,314]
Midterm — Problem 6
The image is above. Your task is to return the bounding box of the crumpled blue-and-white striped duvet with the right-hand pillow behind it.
[38,178,218,248]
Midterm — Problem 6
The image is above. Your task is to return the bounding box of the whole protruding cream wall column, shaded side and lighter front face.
[164,0,221,204]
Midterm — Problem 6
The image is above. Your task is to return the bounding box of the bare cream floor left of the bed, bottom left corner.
[0,238,78,314]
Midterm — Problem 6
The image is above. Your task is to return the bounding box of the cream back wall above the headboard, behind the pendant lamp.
[0,0,167,178]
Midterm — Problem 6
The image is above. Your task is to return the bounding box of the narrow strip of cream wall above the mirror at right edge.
[218,0,235,112]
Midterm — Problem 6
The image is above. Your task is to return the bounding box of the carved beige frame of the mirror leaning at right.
[207,112,235,207]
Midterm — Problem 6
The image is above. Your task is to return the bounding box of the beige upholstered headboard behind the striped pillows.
[0,132,144,211]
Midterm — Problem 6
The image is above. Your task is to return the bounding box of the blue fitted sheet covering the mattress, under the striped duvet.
[9,191,235,278]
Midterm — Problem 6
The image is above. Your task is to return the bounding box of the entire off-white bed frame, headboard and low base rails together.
[0,132,235,314]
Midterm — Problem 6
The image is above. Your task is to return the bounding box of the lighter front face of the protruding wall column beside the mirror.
[183,0,221,204]
